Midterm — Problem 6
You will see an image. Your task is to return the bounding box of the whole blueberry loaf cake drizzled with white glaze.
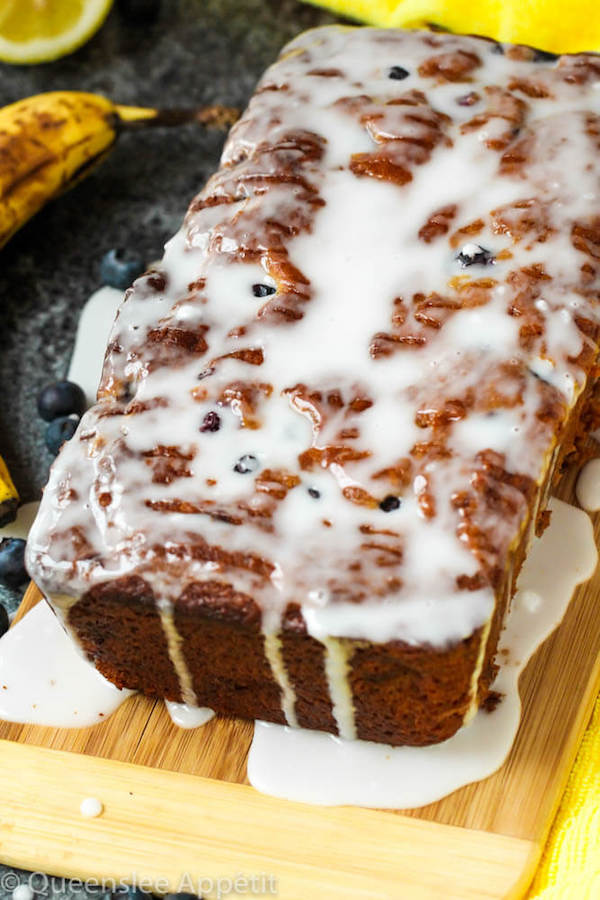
[28,27,600,745]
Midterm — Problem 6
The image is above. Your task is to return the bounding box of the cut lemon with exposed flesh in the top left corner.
[0,0,112,63]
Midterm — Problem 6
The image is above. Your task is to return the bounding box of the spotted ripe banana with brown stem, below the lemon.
[0,91,237,250]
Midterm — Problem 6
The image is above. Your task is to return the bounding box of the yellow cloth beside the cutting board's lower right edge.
[528,697,600,900]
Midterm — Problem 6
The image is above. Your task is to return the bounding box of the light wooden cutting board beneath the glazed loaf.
[0,464,600,900]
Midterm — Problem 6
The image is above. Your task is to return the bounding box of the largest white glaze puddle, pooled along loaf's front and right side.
[248,499,597,809]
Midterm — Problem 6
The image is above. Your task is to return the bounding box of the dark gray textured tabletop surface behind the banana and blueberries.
[0,0,333,898]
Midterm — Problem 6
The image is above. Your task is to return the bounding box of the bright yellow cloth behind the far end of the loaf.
[310,0,600,53]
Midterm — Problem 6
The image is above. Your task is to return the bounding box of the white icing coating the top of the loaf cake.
[24,28,597,660]
